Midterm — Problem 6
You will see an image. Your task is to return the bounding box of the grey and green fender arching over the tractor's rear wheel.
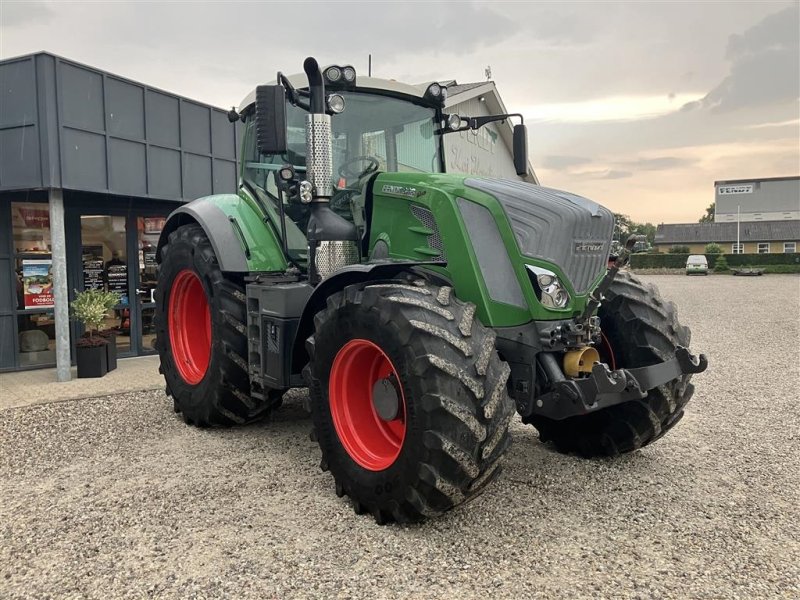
[156,194,288,273]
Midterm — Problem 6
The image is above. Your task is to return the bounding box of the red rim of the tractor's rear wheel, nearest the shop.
[169,269,211,385]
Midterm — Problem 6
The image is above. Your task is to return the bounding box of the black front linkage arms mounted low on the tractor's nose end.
[533,346,708,420]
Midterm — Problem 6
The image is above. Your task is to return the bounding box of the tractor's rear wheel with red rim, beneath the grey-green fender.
[154,224,279,427]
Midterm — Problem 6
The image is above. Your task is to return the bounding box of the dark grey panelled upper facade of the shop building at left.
[0,53,240,201]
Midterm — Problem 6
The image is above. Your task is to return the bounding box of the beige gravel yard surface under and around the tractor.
[0,276,800,598]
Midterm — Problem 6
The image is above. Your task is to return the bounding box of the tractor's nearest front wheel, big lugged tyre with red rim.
[305,281,514,524]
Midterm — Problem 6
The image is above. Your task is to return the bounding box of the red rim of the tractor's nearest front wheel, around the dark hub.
[328,339,406,471]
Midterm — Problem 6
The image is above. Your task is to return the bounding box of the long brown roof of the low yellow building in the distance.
[655,220,800,244]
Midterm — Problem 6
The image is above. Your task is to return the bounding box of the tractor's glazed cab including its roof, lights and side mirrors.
[230,66,527,267]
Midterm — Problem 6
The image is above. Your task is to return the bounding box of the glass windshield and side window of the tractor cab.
[242,92,442,260]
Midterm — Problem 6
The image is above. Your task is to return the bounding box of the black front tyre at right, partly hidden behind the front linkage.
[526,271,694,457]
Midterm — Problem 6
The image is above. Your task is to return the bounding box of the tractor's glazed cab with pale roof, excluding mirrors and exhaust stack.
[239,75,444,262]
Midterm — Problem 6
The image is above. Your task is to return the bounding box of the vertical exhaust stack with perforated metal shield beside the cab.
[303,57,361,284]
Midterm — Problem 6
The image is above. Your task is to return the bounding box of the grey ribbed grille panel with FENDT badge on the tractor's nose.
[464,178,614,294]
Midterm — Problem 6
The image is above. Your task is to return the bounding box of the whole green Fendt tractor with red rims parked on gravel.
[155,58,706,523]
